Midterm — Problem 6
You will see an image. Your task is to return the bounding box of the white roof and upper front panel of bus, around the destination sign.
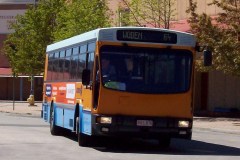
[46,27,196,53]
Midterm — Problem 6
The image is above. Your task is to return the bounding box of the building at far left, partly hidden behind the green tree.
[0,0,43,101]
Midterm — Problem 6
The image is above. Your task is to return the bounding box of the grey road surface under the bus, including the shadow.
[0,113,240,160]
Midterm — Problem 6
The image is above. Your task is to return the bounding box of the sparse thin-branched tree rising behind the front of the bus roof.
[119,0,175,29]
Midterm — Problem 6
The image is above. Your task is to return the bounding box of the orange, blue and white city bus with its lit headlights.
[42,27,210,147]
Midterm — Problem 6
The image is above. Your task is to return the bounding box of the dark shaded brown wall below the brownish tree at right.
[208,71,240,111]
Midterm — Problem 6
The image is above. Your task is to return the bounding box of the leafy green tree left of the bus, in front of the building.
[4,0,65,75]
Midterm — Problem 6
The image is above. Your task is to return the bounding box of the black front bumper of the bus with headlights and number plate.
[92,115,192,139]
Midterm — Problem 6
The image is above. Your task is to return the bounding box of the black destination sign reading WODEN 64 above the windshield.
[117,30,177,44]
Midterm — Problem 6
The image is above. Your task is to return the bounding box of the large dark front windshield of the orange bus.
[100,46,192,94]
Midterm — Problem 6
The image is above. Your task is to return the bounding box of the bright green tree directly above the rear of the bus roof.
[54,0,111,41]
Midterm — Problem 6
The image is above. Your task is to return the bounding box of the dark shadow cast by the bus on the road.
[64,132,240,156]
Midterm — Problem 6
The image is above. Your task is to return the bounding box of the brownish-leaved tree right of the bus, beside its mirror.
[187,0,240,76]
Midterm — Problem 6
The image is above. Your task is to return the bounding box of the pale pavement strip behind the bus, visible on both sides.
[0,101,240,134]
